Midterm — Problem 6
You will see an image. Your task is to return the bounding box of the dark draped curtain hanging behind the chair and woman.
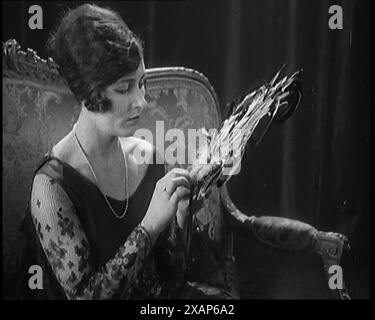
[3,0,370,298]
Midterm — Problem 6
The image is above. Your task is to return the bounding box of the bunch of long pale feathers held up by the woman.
[192,66,301,200]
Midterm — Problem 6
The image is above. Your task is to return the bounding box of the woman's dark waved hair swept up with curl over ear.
[47,4,143,112]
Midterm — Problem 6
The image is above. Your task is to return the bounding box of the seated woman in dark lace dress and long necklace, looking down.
[20,4,198,299]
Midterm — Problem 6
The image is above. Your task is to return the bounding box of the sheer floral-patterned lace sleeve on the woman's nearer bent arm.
[30,174,151,299]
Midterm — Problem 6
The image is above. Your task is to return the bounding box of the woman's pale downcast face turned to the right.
[97,59,146,137]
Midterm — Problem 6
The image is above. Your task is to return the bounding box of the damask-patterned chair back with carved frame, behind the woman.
[3,41,238,298]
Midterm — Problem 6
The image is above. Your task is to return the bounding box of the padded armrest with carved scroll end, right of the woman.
[220,185,350,299]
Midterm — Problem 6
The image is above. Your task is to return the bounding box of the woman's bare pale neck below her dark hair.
[74,107,120,159]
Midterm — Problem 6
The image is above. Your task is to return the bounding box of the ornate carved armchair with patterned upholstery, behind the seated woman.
[3,40,348,298]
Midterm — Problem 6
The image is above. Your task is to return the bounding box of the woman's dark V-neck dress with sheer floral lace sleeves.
[18,154,186,299]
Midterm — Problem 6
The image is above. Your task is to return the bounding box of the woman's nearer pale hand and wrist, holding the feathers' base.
[141,168,191,244]
